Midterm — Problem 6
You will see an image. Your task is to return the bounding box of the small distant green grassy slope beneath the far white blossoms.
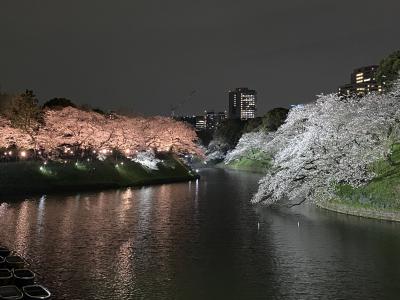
[222,151,271,173]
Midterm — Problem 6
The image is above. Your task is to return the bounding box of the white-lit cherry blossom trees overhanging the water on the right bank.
[250,83,400,206]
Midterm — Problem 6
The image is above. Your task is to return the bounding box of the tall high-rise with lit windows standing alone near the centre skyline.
[229,88,257,120]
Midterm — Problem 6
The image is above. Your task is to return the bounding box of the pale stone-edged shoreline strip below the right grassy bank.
[315,202,400,222]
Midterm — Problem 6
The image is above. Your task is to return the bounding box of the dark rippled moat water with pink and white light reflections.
[0,170,400,299]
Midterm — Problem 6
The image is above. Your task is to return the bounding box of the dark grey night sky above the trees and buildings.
[0,0,400,114]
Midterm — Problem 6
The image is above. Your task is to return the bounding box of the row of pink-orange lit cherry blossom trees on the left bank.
[0,106,202,158]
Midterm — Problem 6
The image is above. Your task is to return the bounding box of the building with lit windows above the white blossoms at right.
[339,65,383,96]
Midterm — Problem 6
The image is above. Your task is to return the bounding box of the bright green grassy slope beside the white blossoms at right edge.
[320,144,400,221]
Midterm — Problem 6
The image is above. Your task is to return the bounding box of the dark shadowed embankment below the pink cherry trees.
[0,155,197,194]
